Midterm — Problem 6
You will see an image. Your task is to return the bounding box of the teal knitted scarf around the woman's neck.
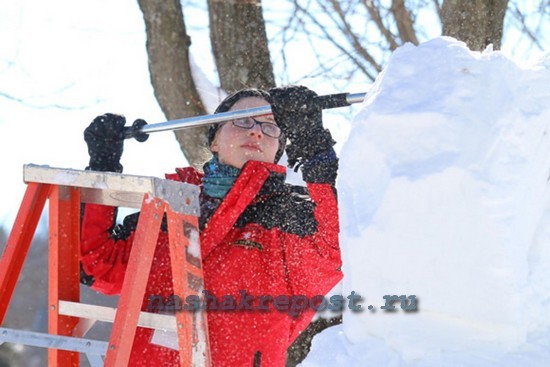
[202,156,241,198]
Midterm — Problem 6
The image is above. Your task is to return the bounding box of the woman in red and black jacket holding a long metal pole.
[81,86,342,367]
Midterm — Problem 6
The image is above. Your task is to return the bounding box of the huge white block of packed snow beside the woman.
[303,37,550,366]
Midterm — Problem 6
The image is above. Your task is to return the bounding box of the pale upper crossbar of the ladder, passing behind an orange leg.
[59,301,177,332]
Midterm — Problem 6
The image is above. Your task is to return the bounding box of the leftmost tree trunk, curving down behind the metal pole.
[138,0,210,169]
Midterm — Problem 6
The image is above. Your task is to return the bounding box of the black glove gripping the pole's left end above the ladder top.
[84,113,126,172]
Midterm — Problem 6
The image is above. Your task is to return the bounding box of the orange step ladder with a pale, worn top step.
[0,165,211,367]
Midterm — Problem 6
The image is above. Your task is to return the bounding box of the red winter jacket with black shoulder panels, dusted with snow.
[81,161,342,367]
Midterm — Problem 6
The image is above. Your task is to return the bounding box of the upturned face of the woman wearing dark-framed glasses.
[210,97,279,169]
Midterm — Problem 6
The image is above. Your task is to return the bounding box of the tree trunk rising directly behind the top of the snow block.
[441,0,508,51]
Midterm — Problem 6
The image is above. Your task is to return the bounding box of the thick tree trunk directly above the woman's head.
[208,0,275,93]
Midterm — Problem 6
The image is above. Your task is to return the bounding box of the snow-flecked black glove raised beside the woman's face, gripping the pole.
[269,85,338,183]
